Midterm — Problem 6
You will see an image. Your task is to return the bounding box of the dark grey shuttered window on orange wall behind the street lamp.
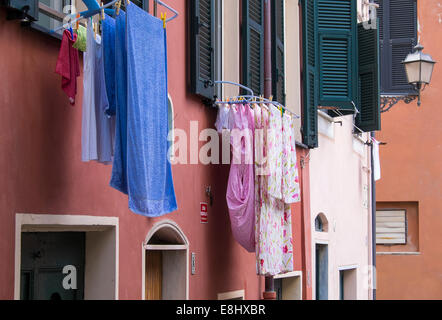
[374,0,417,95]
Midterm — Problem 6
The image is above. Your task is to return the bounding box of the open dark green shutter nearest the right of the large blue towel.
[189,0,215,99]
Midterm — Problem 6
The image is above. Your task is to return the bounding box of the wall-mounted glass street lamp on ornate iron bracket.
[381,44,436,112]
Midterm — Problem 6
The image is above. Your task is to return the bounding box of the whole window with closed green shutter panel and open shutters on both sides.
[301,0,380,148]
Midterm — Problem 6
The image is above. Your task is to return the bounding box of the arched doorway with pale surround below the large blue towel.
[143,220,189,300]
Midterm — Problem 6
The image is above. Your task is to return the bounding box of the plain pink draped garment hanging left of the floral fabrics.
[226,105,255,252]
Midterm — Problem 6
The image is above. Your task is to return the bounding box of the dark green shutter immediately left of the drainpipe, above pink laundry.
[242,0,264,95]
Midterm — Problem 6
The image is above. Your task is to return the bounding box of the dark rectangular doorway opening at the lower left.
[20,232,86,300]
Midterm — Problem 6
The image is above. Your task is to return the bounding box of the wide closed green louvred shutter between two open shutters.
[316,0,357,110]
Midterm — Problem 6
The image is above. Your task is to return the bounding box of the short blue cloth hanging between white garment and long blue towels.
[101,15,116,116]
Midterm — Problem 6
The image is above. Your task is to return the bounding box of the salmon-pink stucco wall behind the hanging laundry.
[0,0,308,299]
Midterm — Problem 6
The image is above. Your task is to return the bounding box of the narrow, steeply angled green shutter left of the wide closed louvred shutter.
[301,0,318,148]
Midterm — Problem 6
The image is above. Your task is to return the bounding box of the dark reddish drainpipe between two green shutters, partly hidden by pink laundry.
[263,0,276,300]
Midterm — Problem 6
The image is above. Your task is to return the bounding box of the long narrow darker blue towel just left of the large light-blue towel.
[110,10,127,194]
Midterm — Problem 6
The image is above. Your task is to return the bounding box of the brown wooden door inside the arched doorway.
[145,250,163,300]
